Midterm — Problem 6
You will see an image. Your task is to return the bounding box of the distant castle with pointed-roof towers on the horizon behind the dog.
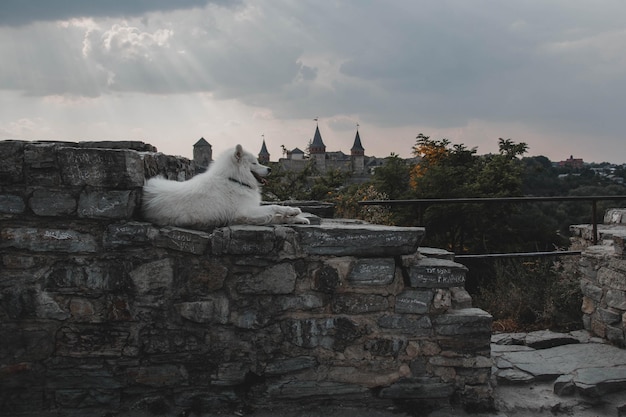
[193,125,383,177]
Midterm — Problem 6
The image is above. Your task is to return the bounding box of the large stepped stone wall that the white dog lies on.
[0,141,493,416]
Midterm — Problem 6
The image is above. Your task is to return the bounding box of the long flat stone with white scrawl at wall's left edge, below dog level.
[0,227,98,253]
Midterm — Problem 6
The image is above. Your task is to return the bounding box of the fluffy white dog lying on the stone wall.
[143,145,309,226]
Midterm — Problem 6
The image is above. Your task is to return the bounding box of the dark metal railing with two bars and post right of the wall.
[359,195,626,258]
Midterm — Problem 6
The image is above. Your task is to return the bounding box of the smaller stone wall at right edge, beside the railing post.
[570,209,626,347]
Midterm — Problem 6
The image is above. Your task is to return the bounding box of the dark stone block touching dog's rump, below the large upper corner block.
[77,190,139,219]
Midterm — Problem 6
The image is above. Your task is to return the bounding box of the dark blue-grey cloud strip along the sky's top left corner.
[0,0,239,26]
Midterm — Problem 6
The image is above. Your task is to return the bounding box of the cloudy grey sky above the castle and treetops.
[0,0,626,163]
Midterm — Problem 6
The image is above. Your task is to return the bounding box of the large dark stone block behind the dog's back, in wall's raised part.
[57,147,144,189]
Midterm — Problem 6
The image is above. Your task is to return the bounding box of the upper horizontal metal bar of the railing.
[359,195,626,206]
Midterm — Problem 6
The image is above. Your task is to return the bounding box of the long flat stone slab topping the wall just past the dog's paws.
[294,223,424,257]
